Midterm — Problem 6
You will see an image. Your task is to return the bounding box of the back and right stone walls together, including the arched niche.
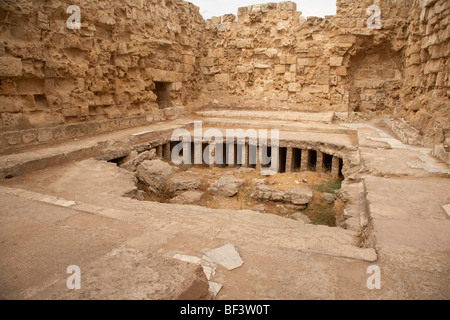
[201,0,450,145]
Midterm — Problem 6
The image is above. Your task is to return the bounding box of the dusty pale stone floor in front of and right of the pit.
[0,117,450,299]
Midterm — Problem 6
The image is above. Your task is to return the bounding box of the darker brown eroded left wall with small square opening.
[0,0,204,149]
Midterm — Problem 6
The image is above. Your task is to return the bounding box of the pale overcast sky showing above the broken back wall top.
[187,0,336,19]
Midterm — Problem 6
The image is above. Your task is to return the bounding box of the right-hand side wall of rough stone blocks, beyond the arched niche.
[395,0,450,147]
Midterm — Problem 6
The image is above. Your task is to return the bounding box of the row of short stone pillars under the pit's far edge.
[156,142,343,178]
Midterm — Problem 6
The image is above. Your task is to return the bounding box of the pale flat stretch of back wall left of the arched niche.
[202,2,346,111]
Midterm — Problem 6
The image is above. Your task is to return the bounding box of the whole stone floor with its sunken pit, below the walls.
[0,111,450,299]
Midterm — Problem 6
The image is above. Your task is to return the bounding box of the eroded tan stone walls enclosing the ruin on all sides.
[0,0,450,151]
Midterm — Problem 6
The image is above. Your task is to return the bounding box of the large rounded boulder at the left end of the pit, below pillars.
[136,160,174,192]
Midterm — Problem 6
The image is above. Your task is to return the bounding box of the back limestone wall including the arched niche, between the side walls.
[202,0,409,112]
